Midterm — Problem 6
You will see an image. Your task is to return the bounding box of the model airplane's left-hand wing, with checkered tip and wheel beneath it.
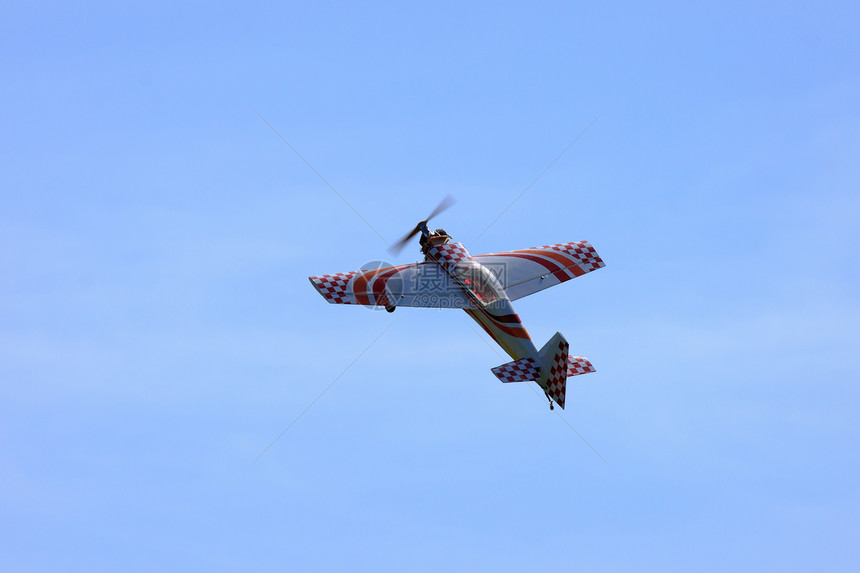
[308,262,475,308]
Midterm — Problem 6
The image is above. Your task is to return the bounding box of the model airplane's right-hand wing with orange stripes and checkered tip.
[472,241,606,300]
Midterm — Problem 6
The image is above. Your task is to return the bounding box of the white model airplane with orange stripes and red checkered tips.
[309,198,605,409]
